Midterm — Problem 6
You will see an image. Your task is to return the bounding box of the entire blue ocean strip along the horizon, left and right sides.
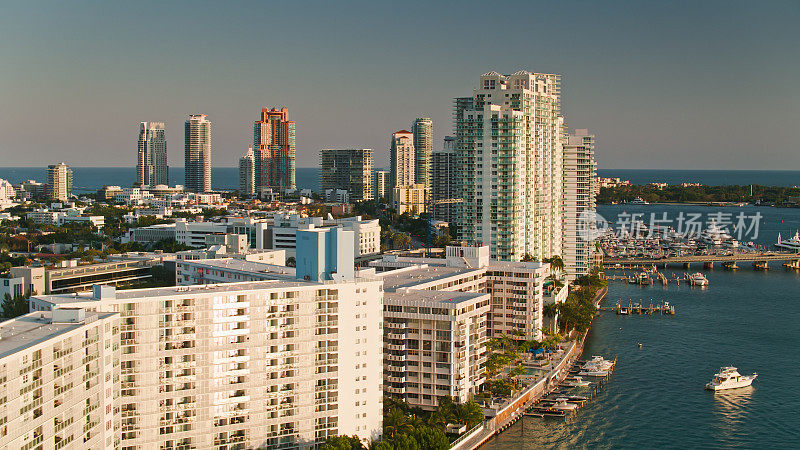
[0,167,800,193]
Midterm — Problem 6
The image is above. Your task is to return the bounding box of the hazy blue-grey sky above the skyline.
[0,0,800,170]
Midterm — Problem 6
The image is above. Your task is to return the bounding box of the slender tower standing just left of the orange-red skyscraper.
[183,114,211,192]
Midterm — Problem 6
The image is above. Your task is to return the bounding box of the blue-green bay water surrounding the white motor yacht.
[484,205,800,450]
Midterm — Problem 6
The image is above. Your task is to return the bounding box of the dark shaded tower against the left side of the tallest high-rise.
[429,136,458,222]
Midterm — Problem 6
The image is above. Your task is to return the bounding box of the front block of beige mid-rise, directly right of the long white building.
[384,288,489,409]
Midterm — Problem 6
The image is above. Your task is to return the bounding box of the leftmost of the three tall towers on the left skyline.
[136,122,169,186]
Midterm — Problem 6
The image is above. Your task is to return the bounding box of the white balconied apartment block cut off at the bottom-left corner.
[0,307,121,449]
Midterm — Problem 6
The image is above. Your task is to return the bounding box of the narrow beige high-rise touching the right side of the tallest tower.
[562,129,597,279]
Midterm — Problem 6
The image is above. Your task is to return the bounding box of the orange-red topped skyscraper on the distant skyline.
[253,108,295,193]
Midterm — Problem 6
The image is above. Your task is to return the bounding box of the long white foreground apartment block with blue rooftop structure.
[34,230,383,449]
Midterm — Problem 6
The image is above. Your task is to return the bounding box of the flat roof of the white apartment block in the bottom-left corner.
[0,311,117,358]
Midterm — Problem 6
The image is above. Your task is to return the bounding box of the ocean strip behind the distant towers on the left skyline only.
[0,167,319,194]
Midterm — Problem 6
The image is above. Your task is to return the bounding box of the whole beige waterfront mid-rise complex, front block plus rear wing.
[370,246,550,409]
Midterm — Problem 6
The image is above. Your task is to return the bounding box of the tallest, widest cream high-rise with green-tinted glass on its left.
[454,71,564,261]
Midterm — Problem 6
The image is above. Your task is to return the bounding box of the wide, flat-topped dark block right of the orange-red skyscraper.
[320,148,373,201]
